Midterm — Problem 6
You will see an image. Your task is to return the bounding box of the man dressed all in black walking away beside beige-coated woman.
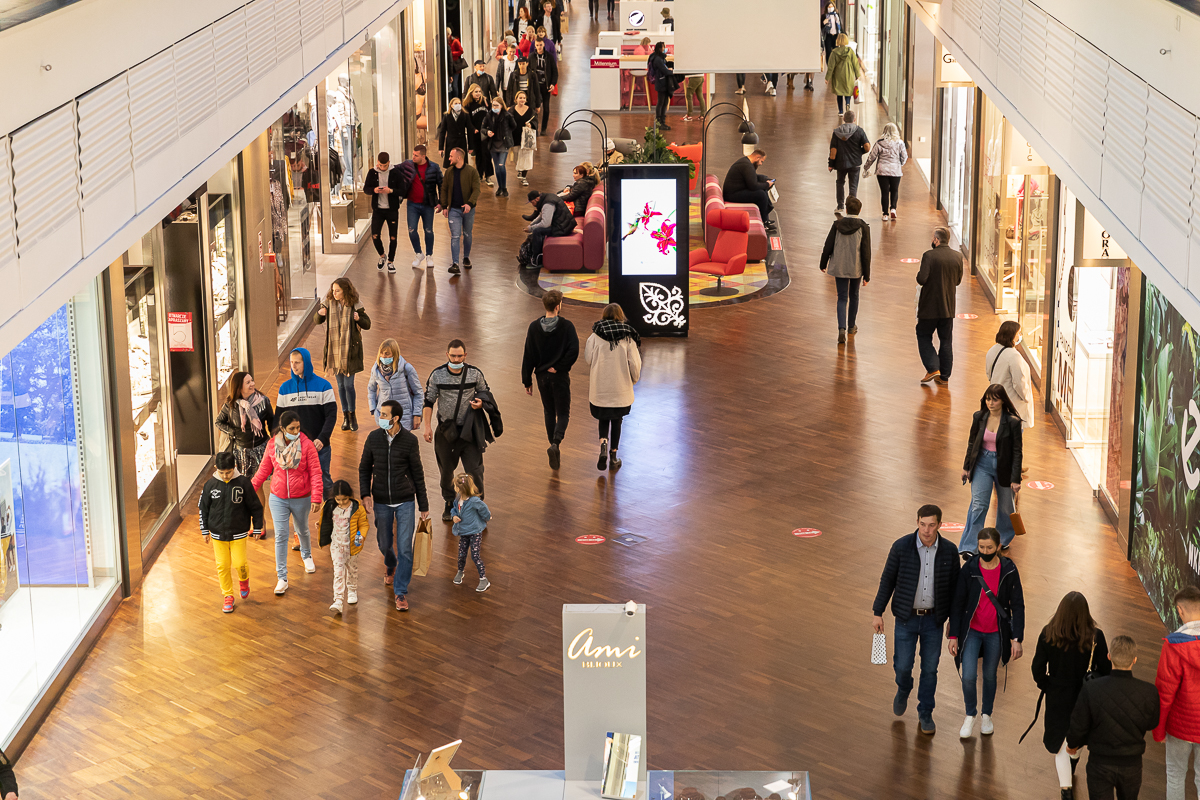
[521,289,580,469]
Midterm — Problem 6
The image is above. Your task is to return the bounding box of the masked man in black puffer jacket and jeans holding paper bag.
[359,401,430,612]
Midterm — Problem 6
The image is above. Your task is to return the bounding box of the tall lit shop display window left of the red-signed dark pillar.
[124,229,172,545]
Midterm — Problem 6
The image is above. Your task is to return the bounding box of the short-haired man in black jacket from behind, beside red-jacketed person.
[1062,636,1159,800]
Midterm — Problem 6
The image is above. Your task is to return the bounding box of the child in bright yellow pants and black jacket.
[199,452,263,614]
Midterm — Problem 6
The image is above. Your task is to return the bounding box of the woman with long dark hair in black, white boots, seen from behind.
[1021,591,1112,800]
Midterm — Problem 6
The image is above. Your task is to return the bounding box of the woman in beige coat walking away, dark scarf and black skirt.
[583,302,642,469]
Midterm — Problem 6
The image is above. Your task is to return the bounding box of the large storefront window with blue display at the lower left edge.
[0,283,120,741]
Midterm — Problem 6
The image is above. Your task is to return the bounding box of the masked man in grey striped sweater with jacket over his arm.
[421,339,490,522]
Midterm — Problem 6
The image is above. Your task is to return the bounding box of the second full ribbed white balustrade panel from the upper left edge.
[76,74,137,253]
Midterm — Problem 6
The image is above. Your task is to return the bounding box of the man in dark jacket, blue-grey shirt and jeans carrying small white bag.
[872,505,959,734]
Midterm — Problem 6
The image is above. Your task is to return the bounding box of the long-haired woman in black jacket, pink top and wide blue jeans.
[959,384,1021,553]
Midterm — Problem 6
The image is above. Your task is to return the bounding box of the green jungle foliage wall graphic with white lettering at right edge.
[1133,282,1200,628]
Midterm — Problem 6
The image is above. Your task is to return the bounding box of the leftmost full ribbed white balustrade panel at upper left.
[12,106,84,302]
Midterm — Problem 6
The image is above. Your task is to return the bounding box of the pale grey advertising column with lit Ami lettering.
[563,604,647,790]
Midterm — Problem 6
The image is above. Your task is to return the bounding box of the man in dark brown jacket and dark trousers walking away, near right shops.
[917,228,962,384]
